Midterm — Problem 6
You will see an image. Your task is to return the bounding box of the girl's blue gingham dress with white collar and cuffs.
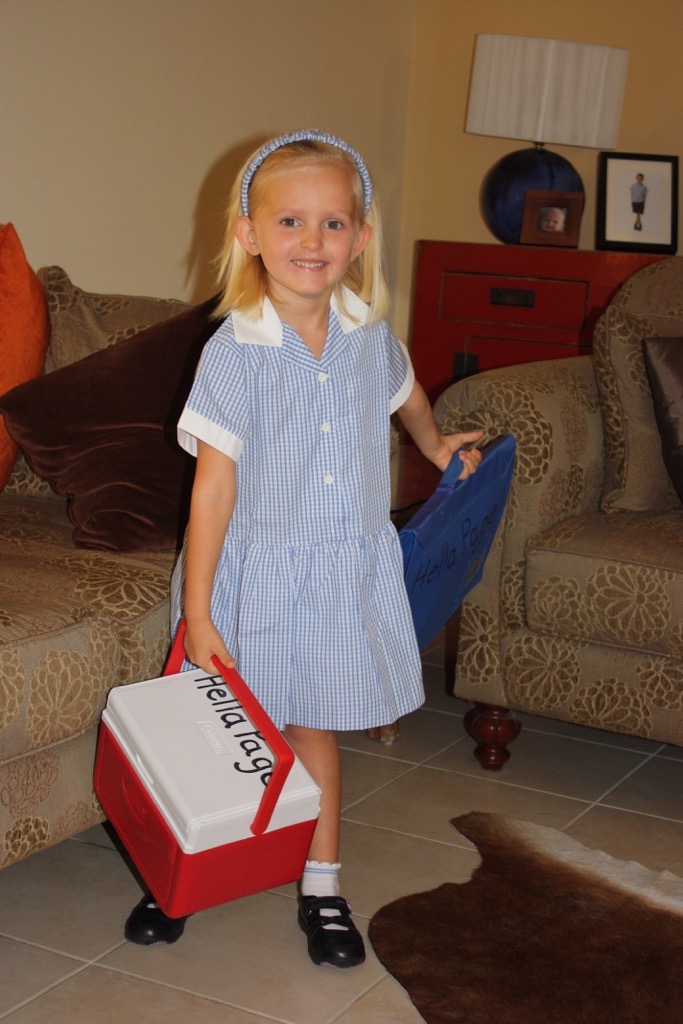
[172,292,424,729]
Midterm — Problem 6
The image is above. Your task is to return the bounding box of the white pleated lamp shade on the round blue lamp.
[465,35,629,150]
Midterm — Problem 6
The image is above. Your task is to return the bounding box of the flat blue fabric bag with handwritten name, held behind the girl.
[398,435,516,650]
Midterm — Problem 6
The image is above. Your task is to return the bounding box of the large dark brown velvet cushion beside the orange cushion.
[0,299,217,551]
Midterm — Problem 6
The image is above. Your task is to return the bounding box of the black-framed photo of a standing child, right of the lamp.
[595,153,678,255]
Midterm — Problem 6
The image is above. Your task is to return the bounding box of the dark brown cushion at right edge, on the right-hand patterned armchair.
[643,338,683,502]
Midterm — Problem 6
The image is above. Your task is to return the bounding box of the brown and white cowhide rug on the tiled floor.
[370,813,683,1024]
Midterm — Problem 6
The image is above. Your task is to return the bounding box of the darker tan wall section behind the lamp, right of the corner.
[394,0,683,331]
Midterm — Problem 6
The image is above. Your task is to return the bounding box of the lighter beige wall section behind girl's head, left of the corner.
[0,0,415,299]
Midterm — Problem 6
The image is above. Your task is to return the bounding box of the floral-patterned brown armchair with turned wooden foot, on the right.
[435,257,683,770]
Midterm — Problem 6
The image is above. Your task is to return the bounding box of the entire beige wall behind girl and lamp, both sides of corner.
[0,0,683,334]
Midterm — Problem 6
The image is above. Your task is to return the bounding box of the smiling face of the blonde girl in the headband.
[237,161,371,306]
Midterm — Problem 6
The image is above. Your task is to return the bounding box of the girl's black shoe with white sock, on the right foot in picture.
[299,896,366,967]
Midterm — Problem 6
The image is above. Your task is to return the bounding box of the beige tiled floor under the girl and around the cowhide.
[0,644,683,1024]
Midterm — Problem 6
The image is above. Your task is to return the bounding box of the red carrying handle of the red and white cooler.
[163,618,294,836]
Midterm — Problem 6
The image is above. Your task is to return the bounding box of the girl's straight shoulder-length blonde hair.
[214,139,389,323]
